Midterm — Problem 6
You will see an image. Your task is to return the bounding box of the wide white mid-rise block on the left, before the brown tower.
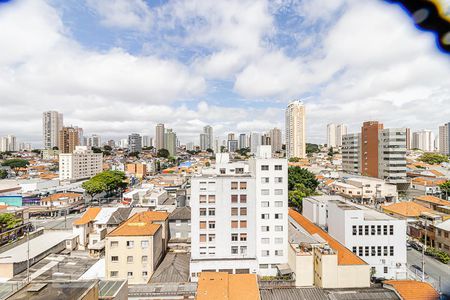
[59,146,103,180]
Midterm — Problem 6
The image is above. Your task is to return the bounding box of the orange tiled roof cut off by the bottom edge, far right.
[383,280,439,300]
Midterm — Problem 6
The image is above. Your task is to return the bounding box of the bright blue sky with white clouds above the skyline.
[0,0,450,147]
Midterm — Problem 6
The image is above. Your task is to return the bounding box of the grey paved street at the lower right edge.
[408,249,450,295]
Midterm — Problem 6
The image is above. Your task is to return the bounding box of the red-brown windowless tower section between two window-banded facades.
[361,121,383,177]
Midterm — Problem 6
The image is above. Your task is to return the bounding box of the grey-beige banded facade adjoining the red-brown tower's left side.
[342,133,361,174]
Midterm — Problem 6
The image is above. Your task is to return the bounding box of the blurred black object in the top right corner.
[386,0,450,53]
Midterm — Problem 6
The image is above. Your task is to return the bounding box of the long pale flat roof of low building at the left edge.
[0,230,74,264]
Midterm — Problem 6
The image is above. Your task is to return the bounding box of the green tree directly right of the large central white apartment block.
[288,167,319,211]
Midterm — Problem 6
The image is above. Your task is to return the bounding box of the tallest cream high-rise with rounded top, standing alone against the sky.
[286,101,306,158]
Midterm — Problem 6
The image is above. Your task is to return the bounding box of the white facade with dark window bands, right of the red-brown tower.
[378,128,407,184]
